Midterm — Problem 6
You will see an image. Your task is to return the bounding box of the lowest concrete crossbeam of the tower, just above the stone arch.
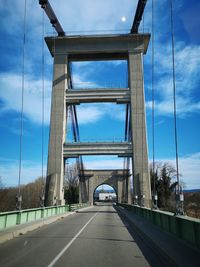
[63,142,132,158]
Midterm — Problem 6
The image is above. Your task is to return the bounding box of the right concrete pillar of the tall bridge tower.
[129,52,151,207]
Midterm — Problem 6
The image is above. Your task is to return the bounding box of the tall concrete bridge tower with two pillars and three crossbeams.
[45,34,151,207]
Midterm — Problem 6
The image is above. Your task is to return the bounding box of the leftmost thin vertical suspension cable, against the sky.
[17,0,26,210]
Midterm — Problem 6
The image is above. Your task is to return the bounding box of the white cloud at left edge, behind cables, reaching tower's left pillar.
[0,73,51,124]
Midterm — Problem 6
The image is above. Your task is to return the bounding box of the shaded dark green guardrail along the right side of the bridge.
[118,204,200,249]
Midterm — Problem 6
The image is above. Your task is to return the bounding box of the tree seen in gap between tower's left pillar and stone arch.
[64,164,79,204]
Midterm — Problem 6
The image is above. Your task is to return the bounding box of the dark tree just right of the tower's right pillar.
[150,162,177,209]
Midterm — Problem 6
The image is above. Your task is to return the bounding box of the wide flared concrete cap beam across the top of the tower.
[45,34,150,58]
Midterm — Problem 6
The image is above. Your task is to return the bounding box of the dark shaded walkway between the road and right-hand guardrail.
[117,204,200,267]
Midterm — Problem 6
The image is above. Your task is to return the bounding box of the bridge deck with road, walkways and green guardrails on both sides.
[0,203,200,267]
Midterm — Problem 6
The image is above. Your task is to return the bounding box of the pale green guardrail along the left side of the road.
[0,203,89,231]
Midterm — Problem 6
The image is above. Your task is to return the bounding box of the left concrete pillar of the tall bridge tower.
[45,55,67,206]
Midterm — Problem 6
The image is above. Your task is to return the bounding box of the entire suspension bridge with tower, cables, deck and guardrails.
[0,0,200,267]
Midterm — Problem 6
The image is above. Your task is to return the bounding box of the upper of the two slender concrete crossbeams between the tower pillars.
[66,88,130,104]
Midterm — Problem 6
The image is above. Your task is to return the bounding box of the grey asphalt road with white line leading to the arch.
[0,205,172,267]
